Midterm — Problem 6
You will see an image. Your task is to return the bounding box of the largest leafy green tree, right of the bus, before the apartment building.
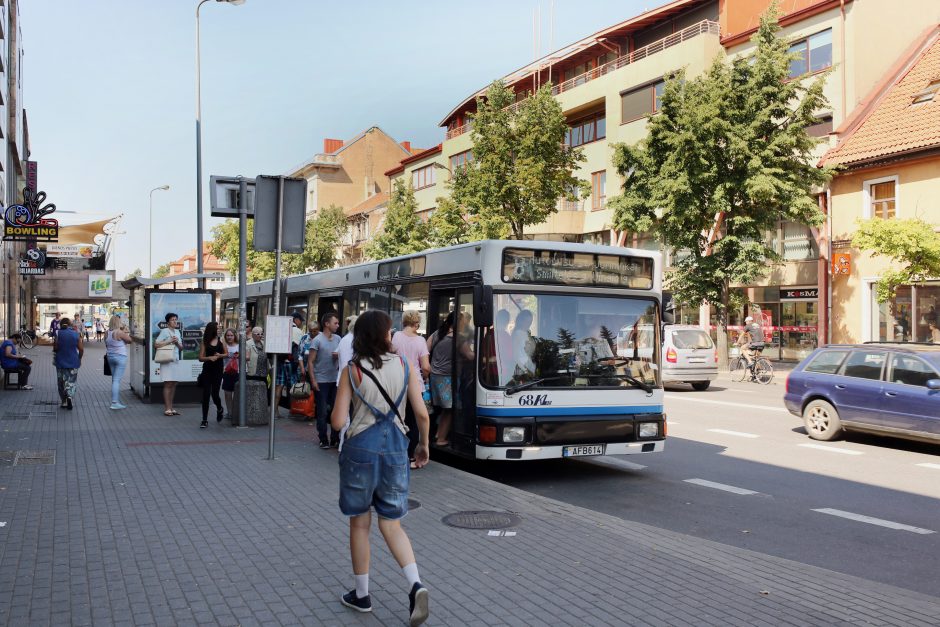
[610,5,831,366]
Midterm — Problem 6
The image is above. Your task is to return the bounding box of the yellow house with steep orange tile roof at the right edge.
[824,20,940,342]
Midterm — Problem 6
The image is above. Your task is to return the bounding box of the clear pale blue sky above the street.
[20,0,652,278]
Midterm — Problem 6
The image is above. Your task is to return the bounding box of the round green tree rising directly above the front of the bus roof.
[449,81,586,239]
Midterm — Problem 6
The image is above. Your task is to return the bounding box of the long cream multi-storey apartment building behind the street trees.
[388,0,940,359]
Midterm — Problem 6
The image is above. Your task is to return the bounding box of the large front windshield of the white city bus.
[480,293,660,390]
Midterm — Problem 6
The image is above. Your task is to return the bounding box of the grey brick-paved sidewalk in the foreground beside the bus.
[0,346,940,626]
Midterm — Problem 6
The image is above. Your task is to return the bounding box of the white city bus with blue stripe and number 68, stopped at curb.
[222,241,666,460]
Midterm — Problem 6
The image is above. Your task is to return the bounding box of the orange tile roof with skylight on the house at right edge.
[822,24,940,165]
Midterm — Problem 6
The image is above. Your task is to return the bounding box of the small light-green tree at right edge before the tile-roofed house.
[852,218,940,303]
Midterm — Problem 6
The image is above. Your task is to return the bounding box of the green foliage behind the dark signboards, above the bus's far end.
[210,205,348,281]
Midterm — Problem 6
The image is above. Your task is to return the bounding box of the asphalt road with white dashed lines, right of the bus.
[447,376,940,596]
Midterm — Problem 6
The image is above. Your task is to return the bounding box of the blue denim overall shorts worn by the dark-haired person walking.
[339,361,411,520]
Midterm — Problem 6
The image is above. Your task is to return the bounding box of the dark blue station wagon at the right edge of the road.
[783,342,940,442]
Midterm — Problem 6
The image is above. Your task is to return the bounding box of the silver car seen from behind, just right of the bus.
[663,324,718,391]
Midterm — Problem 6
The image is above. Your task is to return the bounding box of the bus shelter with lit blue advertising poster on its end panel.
[121,272,222,403]
